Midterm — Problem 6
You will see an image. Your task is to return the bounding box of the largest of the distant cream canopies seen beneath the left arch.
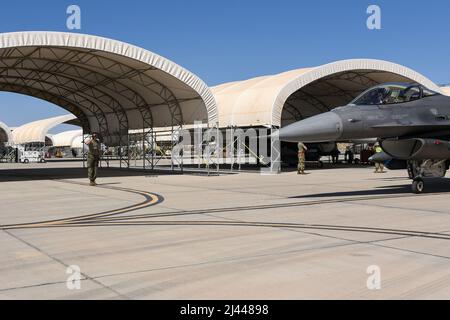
[12,114,76,145]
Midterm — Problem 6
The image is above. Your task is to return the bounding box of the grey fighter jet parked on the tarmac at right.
[279,83,450,193]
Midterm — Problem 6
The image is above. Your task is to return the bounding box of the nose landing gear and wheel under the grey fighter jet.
[408,159,448,194]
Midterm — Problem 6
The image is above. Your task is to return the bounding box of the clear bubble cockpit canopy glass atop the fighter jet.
[350,83,437,105]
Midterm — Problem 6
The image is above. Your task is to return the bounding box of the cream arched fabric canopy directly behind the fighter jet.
[212,59,440,127]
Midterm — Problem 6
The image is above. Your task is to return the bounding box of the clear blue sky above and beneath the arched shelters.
[0,0,450,130]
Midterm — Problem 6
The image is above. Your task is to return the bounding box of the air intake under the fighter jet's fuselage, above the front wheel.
[381,138,450,160]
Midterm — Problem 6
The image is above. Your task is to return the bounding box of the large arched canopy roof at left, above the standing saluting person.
[0,32,217,145]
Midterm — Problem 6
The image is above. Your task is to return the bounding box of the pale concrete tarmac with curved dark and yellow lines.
[0,162,450,299]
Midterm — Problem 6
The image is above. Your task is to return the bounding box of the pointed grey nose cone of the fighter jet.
[279,112,342,143]
